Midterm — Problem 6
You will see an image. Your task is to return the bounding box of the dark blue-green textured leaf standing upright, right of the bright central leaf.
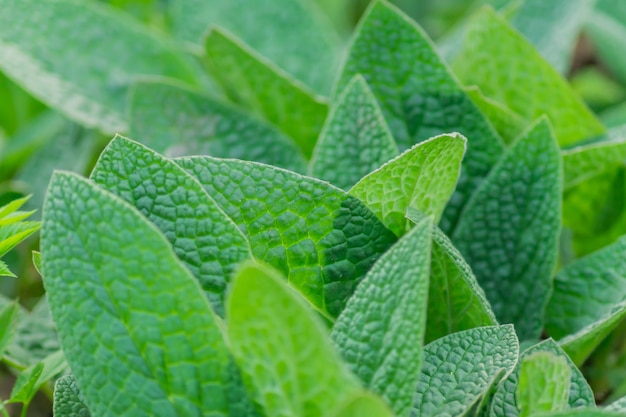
[452,119,562,340]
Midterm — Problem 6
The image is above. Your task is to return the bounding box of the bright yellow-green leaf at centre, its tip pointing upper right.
[350,134,467,236]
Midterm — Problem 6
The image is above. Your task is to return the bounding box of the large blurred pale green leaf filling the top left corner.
[0,0,196,132]
